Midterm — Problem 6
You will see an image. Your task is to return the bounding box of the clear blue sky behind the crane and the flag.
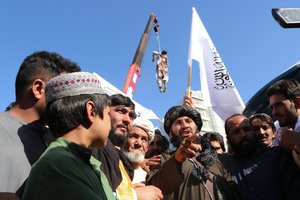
[0,0,300,122]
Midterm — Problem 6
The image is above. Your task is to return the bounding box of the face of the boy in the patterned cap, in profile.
[94,106,111,147]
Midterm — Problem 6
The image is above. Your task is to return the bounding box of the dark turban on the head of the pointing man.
[164,106,202,134]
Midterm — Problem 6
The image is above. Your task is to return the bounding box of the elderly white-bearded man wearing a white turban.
[123,118,155,184]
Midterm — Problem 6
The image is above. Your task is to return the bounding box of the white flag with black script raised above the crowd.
[188,7,245,121]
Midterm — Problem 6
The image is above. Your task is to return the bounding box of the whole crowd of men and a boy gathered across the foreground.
[0,51,300,200]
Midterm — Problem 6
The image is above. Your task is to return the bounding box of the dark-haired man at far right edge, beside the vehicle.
[266,80,300,166]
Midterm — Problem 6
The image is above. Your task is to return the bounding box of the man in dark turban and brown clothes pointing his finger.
[147,106,239,200]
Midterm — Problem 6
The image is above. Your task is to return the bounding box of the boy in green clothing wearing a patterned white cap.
[22,72,115,200]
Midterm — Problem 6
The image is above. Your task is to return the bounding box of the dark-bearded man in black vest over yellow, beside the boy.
[93,94,163,200]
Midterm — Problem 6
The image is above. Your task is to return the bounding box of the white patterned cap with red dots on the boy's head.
[45,72,105,103]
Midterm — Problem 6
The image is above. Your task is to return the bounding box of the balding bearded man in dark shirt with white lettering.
[220,114,300,200]
